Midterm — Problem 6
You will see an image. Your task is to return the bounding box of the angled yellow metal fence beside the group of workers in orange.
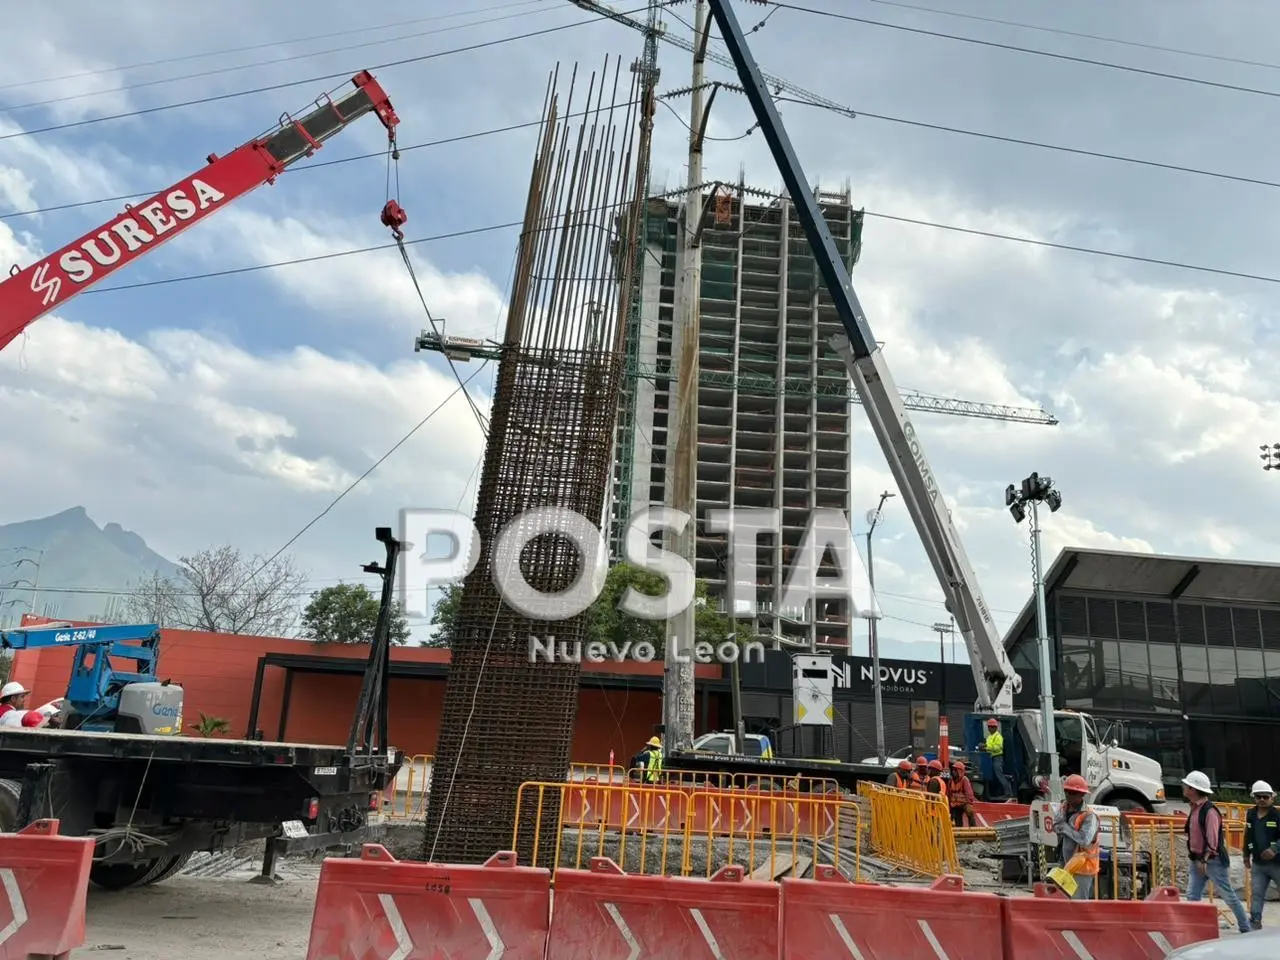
[858,781,963,877]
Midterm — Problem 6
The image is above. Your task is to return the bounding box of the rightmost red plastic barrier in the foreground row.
[1005,883,1219,960]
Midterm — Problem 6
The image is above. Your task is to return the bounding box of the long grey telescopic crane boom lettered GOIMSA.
[710,0,1023,713]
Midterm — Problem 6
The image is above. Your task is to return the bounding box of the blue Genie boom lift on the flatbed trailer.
[0,623,183,736]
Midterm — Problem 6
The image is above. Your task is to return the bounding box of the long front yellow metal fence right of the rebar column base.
[511,782,861,879]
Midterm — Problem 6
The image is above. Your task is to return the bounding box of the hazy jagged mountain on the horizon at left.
[0,507,178,625]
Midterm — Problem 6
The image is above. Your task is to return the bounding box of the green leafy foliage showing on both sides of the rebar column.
[431,563,733,653]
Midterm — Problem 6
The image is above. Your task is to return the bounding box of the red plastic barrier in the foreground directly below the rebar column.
[306,844,550,960]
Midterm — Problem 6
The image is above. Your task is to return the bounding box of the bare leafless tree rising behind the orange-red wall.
[124,547,306,636]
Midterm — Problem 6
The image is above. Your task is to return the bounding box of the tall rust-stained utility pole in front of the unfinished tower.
[662,0,716,750]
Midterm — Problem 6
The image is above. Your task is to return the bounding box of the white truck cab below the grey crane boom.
[1016,710,1165,813]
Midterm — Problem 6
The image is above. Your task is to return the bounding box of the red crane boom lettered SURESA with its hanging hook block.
[0,70,406,349]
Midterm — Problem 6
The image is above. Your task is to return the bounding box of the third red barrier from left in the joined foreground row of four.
[778,868,998,960]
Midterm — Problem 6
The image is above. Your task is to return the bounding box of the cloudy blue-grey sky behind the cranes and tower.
[0,0,1280,658]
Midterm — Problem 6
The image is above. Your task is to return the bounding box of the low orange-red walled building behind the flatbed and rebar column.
[12,616,727,763]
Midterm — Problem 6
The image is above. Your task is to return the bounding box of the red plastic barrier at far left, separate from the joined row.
[0,820,93,960]
